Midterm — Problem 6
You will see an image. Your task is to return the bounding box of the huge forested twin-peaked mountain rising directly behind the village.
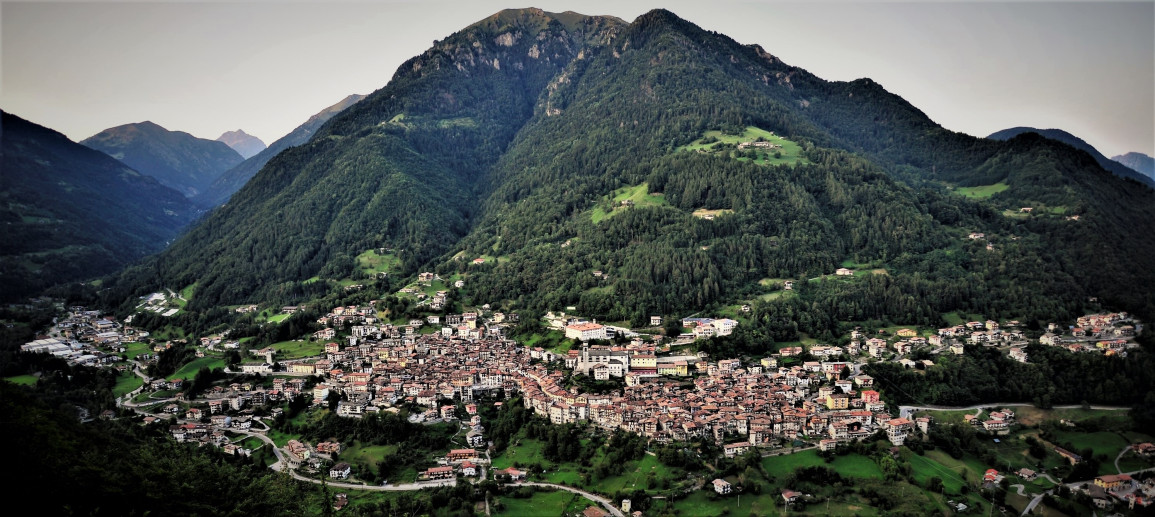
[109,9,1155,332]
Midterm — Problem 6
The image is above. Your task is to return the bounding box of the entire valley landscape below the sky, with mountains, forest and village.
[0,8,1155,516]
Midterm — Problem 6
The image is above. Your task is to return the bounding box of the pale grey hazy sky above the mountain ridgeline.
[0,0,1155,156]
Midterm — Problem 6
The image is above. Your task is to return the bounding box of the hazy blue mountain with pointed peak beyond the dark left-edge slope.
[80,121,244,197]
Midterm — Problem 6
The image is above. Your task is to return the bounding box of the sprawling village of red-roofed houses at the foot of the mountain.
[23,293,1142,493]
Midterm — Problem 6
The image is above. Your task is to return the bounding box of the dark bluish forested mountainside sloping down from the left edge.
[0,112,196,301]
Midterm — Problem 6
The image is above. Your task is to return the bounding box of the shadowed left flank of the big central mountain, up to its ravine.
[106,9,621,308]
